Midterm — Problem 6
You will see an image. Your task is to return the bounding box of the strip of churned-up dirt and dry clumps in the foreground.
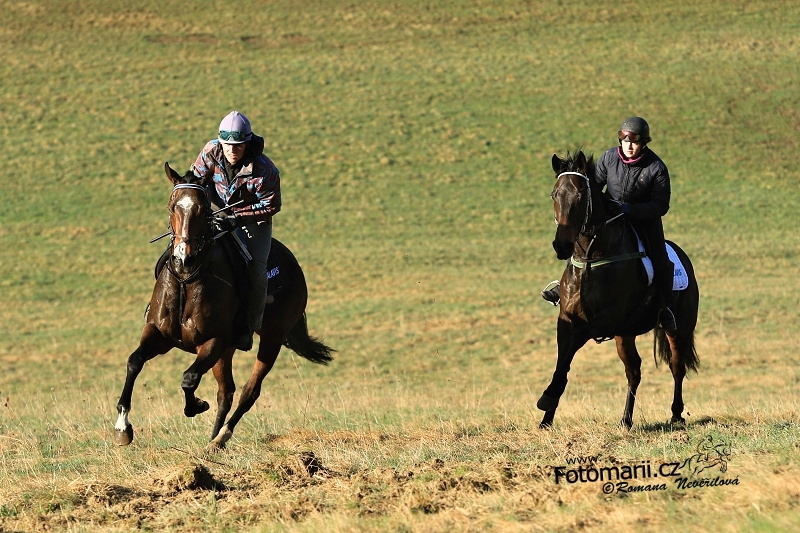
[0,451,546,530]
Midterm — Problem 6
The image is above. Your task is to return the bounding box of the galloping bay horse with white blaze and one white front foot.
[115,163,334,450]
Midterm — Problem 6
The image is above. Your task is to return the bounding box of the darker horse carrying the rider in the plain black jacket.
[537,151,700,428]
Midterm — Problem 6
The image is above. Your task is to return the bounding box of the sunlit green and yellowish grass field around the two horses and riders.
[0,0,800,532]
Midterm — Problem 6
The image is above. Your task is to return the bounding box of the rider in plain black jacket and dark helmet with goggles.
[542,117,677,331]
